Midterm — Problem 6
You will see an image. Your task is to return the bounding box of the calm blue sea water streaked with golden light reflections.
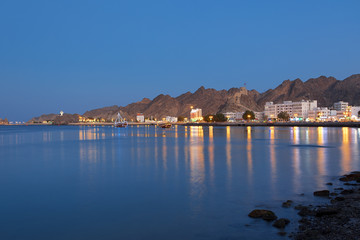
[0,126,360,240]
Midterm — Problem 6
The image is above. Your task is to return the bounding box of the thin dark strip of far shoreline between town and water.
[7,122,360,128]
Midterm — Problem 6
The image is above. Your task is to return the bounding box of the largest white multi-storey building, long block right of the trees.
[264,100,317,120]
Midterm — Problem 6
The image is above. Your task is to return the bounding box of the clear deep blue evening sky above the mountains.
[0,0,360,121]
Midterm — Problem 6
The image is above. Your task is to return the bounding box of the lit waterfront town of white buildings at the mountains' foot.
[27,100,360,124]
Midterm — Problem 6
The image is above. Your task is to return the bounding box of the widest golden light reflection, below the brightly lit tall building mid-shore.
[189,126,205,198]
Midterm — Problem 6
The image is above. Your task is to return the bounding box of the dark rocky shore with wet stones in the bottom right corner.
[248,171,360,240]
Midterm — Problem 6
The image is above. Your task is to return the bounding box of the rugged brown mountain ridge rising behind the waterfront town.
[30,74,360,121]
